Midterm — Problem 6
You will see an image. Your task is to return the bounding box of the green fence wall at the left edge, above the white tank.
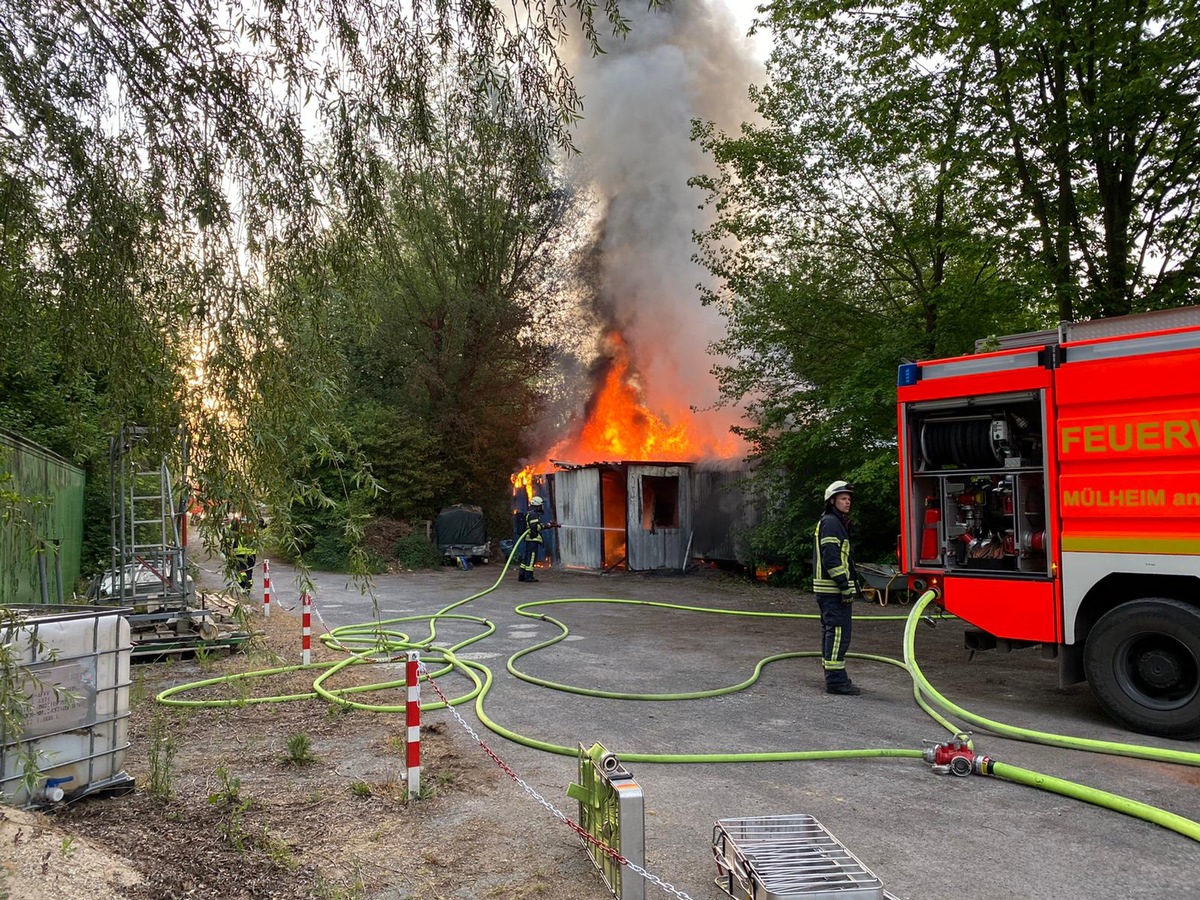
[0,428,84,604]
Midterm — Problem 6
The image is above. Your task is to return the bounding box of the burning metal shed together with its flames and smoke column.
[514,0,761,571]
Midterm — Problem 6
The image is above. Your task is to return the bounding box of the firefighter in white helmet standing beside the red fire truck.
[812,481,862,695]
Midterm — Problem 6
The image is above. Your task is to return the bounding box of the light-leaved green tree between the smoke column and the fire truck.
[695,7,1036,564]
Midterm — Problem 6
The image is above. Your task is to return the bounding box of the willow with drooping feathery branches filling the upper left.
[0,0,657,571]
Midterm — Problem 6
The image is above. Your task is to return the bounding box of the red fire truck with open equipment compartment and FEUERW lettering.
[898,307,1200,738]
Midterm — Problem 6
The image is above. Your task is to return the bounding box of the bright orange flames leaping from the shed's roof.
[512,330,738,498]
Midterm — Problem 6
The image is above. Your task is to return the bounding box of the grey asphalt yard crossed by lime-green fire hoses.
[246,563,1200,900]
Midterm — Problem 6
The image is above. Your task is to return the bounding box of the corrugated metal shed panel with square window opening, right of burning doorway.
[626,463,692,571]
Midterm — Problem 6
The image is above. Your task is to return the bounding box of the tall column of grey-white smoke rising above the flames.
[544,0,762,460]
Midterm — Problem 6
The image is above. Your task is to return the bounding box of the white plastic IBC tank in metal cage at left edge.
[0,606,132,805]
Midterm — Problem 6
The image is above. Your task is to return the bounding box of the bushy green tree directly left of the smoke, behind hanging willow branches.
[331,79,571,535]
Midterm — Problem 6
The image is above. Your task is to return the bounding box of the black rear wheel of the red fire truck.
[1084,598,1200,739]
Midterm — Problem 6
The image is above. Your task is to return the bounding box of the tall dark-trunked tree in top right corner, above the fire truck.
[769,0,1200,319]
